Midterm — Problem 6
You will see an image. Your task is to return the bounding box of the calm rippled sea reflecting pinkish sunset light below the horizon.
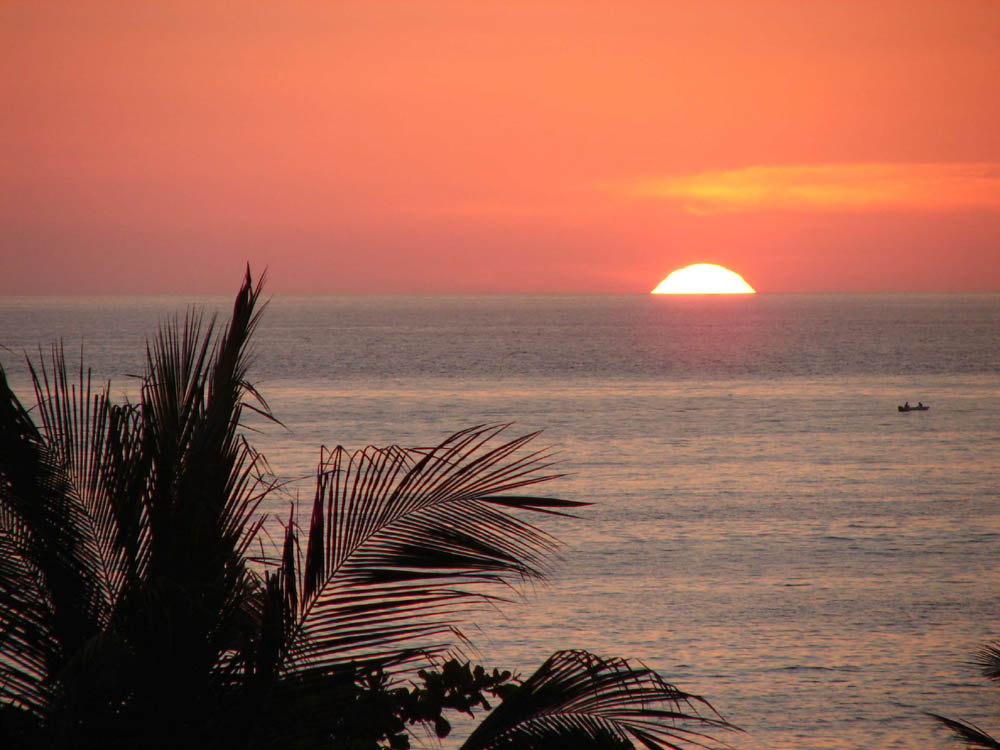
[0,295,1000,750]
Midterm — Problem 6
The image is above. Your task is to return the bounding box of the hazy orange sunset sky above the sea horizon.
[0,0,1000,294]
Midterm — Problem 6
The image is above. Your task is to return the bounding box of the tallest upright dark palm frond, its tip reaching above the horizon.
[126,269,282,696]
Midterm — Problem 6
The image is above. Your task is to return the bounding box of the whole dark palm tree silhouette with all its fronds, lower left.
[0,268,734,750]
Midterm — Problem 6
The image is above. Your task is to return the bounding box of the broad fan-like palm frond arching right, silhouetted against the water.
[290,425,584,680]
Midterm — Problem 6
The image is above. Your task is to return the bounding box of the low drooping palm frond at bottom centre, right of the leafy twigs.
[461,651,735,750]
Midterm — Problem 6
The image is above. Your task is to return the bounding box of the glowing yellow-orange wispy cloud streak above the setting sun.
[628,163,1000,213]
